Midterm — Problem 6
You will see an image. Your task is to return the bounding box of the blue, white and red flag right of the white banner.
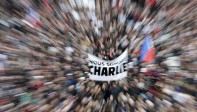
[140,35,155,62]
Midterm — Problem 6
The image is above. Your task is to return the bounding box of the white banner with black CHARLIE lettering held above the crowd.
[88,49,128,81]
